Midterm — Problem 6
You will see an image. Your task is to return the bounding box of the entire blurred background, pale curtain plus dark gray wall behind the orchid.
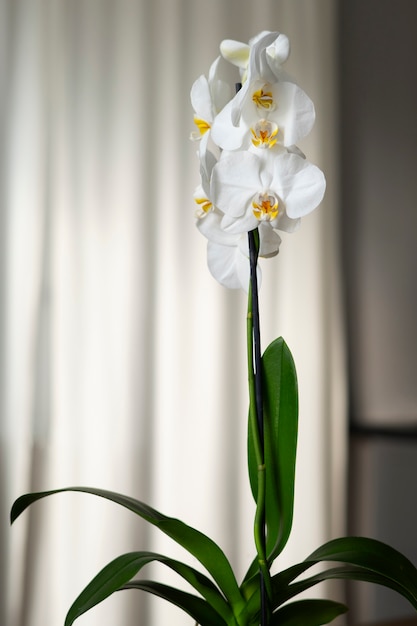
[0,0,417,626]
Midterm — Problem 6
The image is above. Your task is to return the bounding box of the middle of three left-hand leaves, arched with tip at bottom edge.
[65,552,232,626]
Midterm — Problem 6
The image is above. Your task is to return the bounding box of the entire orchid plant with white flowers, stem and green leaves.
[11,32,417,626]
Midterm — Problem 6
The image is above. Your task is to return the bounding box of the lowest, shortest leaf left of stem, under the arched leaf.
[123,580,226,626]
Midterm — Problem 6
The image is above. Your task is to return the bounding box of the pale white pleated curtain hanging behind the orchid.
[0,0,345,626]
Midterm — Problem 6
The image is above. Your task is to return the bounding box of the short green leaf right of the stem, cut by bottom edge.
[271,600,348,626]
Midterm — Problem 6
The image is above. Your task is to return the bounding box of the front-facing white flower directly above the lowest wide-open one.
[211,80,315,150]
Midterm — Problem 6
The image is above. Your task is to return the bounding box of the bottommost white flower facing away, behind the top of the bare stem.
[197,209,281,292]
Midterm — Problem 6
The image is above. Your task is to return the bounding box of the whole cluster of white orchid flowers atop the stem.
[191,31,326,291]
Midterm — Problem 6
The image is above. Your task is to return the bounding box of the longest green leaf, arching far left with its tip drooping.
[11,487,244,612]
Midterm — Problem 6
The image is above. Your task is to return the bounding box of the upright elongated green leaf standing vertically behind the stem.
[247,337,298,564]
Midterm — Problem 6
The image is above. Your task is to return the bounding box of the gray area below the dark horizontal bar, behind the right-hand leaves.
[348,436,417,624]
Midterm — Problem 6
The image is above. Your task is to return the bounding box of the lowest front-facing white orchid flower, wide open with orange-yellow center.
[210,150,326,233]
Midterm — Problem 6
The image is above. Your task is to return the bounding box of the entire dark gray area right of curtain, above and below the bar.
[339,0,417,624]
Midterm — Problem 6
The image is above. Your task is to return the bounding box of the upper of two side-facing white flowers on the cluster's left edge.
[191,56,232,140]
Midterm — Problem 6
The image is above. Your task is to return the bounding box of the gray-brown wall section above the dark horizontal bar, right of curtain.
[341,0,417,425]
